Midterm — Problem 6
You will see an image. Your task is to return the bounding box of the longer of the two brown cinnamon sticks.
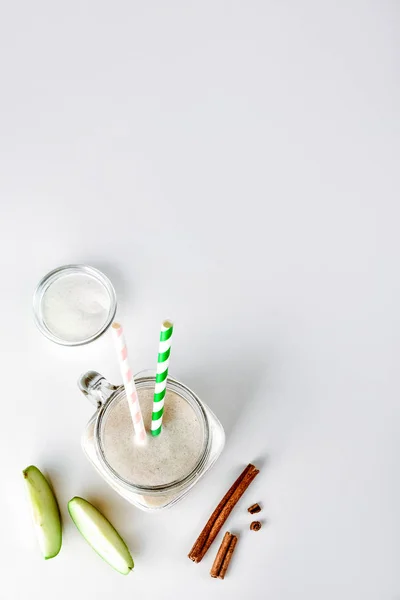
[188,464,259,562]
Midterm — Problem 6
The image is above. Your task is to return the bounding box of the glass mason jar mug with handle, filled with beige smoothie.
[78,371,225,511]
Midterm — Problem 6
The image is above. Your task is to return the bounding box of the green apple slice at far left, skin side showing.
[23,465,62,560]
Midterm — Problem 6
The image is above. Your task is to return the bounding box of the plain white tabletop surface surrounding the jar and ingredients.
[0,0,400,600]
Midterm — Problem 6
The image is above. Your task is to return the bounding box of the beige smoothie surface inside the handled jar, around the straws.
[102,388,204,486]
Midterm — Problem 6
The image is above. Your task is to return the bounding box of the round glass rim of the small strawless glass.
[32,264,117,346]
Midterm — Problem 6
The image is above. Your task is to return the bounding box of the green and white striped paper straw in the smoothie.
[151,321,174,436]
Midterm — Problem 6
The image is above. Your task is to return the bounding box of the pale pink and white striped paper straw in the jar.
[111,323,146,443]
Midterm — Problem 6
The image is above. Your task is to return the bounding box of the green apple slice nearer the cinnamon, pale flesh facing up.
[68,497,133,575]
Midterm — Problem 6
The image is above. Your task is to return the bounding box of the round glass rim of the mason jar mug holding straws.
[93,376,211,495]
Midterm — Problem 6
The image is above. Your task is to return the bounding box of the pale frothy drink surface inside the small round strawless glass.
[42,273,110,342]
